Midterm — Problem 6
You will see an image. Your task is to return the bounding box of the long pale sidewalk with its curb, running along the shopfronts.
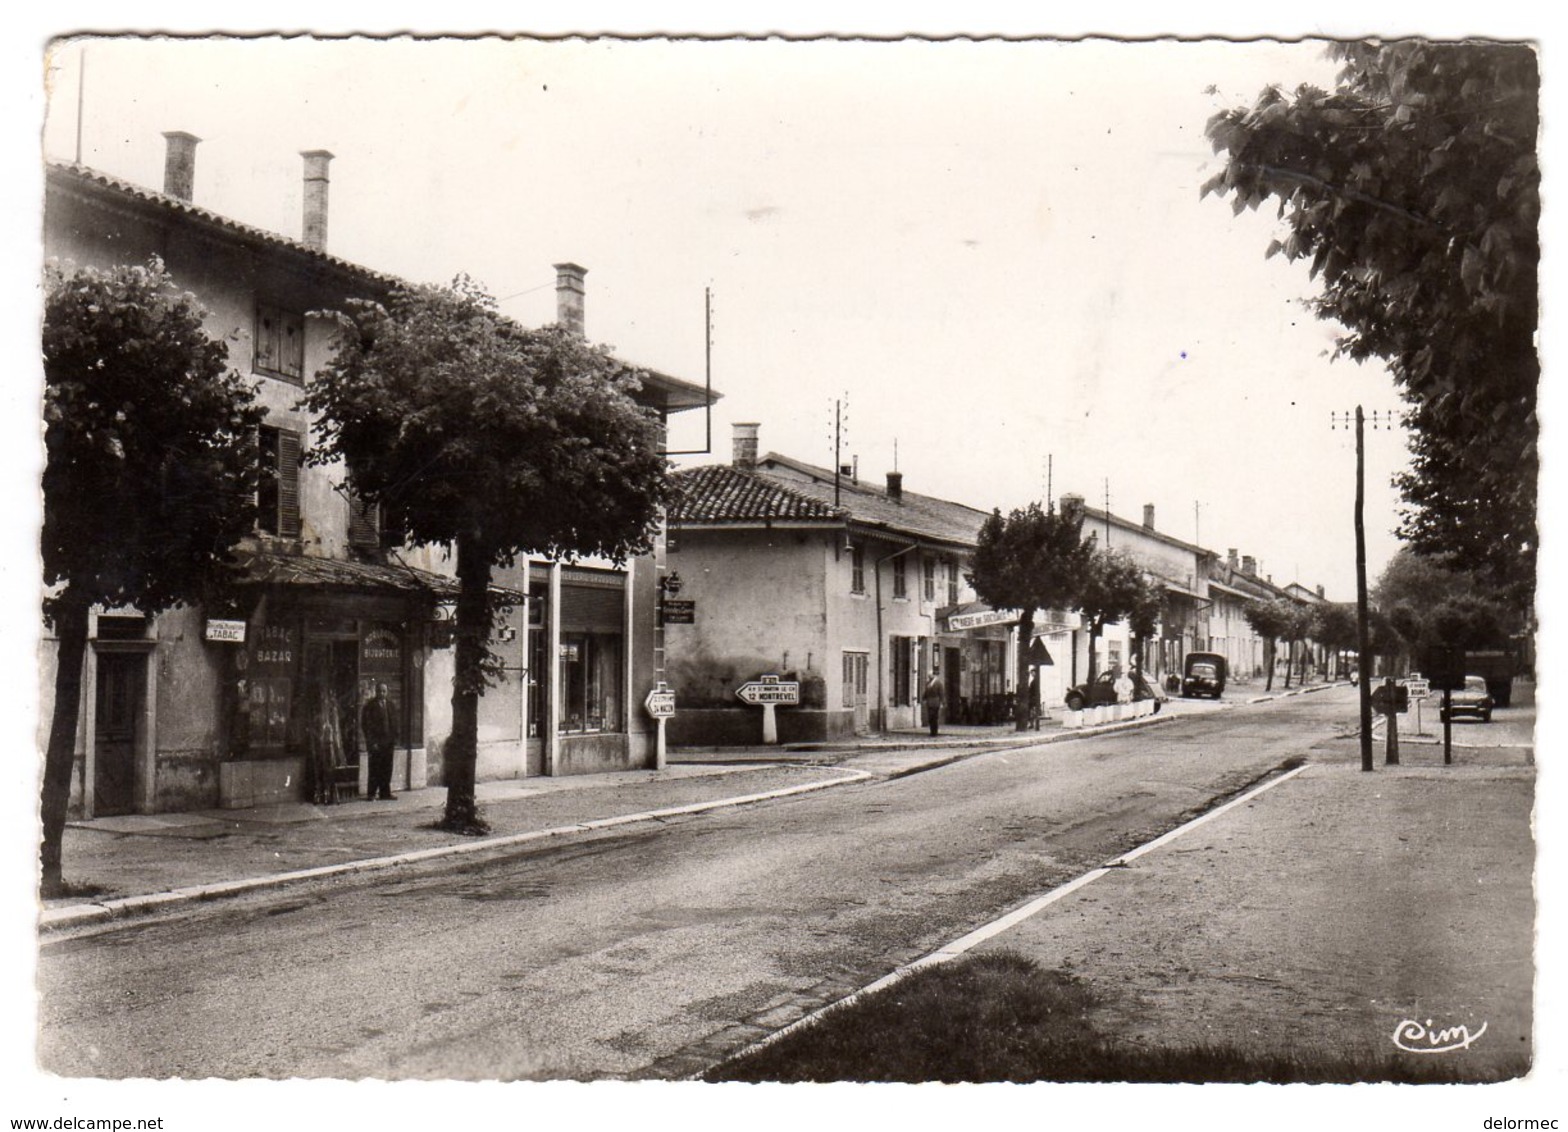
[39,680,1348,930]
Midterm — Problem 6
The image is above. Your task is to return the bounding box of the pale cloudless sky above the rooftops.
[33,38,1406,600]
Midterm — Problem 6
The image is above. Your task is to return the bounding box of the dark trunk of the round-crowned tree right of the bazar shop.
[441,535,491,834]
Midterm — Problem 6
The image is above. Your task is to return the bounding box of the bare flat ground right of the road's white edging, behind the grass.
[978,707,1535,1077]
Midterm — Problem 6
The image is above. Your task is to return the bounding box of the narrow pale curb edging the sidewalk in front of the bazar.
[38,767,875,933]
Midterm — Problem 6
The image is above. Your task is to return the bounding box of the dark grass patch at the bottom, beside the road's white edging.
[704,952,1529,1085]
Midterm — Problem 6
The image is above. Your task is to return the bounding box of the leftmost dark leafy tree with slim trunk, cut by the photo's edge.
[39,260,263,895]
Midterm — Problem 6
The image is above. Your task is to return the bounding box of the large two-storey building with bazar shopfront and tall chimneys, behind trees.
[41,133,707,817]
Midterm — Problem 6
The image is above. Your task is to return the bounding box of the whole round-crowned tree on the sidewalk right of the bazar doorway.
[306,278,671,833]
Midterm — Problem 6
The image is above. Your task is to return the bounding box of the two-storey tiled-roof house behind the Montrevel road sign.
[665,423,1077,743]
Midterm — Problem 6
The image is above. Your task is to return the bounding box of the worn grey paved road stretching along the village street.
[39,693,1353,1079]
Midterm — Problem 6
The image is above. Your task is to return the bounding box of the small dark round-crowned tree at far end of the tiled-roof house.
[969,503,1090,731]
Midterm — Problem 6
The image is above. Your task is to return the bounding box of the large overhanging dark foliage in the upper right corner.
[1203,39,1540,611]
